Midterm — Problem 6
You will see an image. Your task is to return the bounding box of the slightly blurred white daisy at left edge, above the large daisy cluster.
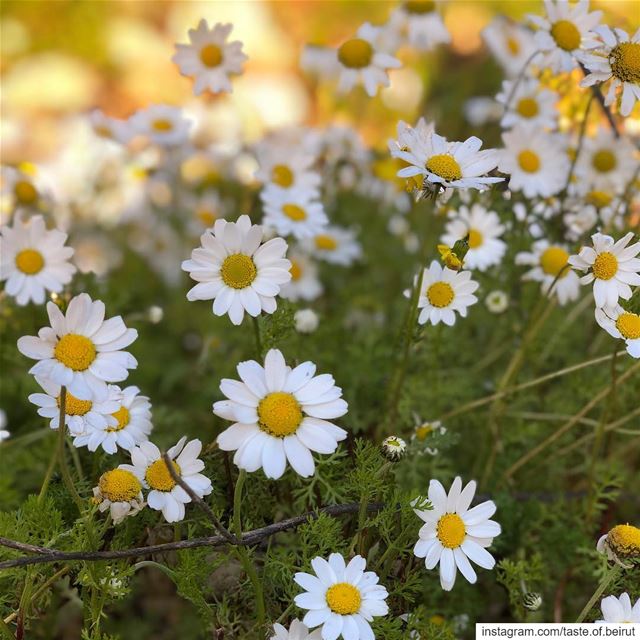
[0,214,76,306]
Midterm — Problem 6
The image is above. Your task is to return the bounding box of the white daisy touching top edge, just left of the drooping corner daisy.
[528,0,602,73]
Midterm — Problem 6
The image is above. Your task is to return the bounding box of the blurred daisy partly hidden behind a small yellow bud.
[440,203,507,271]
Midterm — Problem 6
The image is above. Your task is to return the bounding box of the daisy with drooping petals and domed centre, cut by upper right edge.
[582,25,640,116]
